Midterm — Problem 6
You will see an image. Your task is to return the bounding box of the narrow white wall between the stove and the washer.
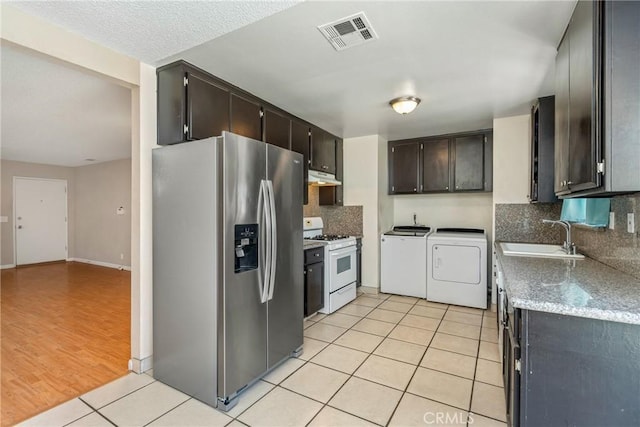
[343,135,393,288]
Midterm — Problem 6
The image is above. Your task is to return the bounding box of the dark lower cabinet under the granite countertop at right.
[503,302,640,427]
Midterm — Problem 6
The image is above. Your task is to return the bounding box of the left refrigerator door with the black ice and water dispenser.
[220,132,268,400]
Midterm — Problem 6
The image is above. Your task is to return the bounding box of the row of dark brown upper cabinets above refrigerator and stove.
[157,61,343,205]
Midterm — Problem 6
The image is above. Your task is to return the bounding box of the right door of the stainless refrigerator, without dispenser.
[267,145,304,368]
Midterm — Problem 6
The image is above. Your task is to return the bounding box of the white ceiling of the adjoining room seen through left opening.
[0,43,131,166]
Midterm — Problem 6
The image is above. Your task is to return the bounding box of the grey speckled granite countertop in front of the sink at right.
[495,242,640,325]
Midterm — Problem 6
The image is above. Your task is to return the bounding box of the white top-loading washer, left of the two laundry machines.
[380,225,431,298]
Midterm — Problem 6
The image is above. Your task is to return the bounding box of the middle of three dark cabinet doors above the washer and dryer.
[421,139,449,193]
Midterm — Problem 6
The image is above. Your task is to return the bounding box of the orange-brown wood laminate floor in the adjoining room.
[0,262,131,426]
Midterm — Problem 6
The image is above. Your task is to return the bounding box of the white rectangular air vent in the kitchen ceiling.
[318,12,378,50]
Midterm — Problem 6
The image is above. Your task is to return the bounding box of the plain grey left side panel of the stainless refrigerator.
[153,138,221,406]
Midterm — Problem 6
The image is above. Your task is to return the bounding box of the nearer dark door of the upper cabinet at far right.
[568,1,600,192]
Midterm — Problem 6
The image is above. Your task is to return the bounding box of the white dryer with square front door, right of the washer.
[427,228,488,309]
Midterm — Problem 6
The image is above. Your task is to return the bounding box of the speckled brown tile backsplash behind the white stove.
[303,186,362,236]
